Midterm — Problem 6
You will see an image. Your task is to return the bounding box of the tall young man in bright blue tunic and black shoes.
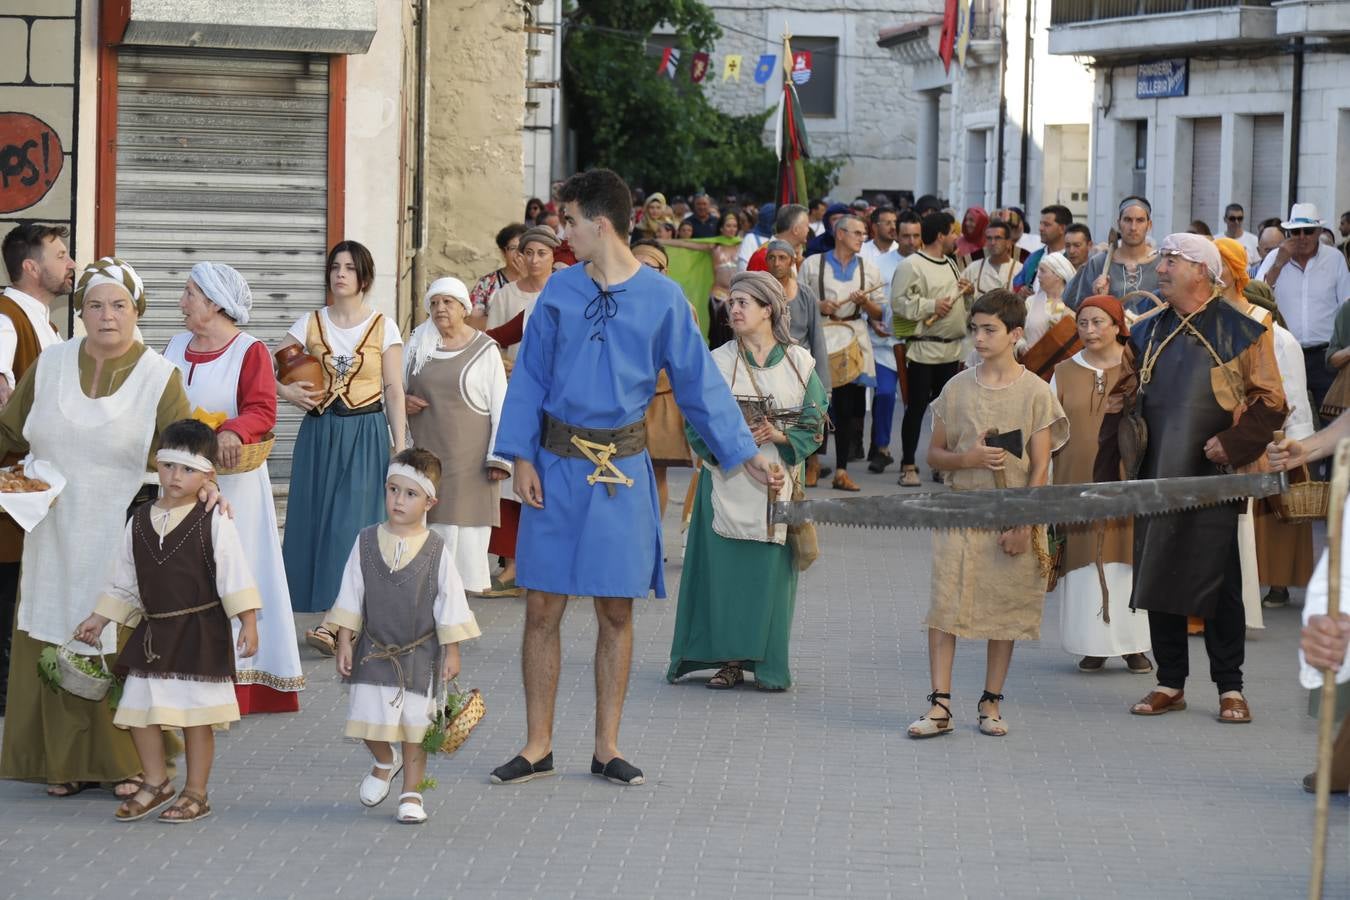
[491,169,783,784]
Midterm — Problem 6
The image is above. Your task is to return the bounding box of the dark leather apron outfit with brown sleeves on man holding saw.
[1094,300,1285,694]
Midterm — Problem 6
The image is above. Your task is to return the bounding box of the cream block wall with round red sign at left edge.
[0,0,79,248]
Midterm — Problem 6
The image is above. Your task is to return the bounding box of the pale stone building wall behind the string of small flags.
[702,0,948,200]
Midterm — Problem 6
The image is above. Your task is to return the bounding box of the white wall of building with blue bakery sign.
[1091,54,1350,242]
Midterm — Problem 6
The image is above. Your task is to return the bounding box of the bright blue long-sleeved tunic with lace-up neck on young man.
[494,263,757,596]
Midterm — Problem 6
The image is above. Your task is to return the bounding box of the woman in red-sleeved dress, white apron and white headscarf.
[165,262,305,715]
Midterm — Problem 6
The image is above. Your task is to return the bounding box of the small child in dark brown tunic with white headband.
[76,420,262,823]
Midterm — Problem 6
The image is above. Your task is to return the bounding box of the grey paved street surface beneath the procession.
[0,431,1350,899]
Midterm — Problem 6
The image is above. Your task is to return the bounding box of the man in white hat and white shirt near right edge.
[1257,204,1350,409]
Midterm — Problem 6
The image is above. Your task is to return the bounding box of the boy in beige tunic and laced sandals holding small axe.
[909,289,1069,738]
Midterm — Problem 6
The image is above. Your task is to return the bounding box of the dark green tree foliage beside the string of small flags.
[563,0,841,198]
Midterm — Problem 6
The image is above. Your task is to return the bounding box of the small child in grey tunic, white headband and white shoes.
[327,447,479,824]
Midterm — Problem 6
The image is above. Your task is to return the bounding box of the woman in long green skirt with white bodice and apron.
[666,271,828,691]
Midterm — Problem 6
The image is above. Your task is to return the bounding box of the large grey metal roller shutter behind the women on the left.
[116,47,328,486]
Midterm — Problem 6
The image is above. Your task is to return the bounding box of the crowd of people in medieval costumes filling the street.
[0,170,1350,823]
